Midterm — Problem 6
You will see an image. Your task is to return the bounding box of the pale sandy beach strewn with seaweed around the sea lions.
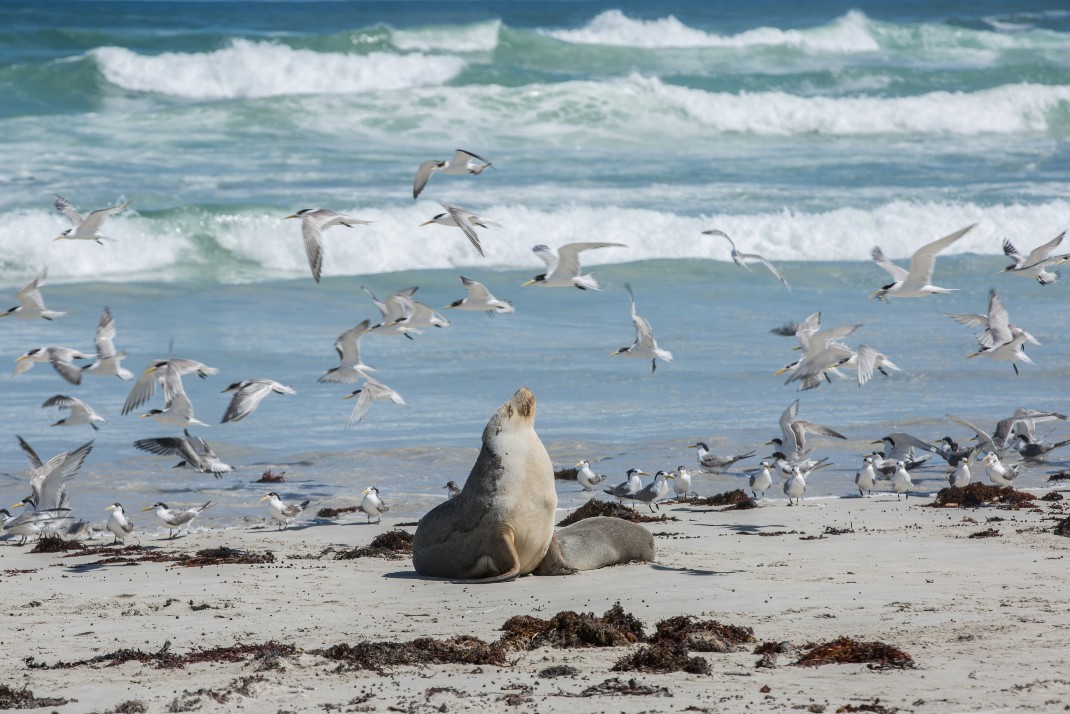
[0,486,1070,712]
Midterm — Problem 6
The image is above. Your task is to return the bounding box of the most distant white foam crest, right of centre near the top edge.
[542,10,880,52]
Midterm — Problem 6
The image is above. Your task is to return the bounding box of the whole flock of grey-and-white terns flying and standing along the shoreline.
[0,149,1070,543]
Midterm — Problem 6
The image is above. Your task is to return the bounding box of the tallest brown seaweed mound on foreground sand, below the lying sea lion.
[498,603,645,650]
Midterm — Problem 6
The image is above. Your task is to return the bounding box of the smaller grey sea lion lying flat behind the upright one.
[532,516,654,575]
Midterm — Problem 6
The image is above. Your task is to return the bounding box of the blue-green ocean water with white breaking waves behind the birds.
[0,1,1070,528]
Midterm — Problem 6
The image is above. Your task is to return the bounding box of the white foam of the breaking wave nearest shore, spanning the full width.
[0,200,1070,286]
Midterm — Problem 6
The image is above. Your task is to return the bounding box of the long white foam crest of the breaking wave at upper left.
[90,40,465,100]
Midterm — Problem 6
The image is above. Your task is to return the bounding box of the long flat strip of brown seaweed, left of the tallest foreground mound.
[310,636,507,672]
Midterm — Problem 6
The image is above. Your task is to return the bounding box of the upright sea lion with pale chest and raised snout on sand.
[412,388,557,582]
